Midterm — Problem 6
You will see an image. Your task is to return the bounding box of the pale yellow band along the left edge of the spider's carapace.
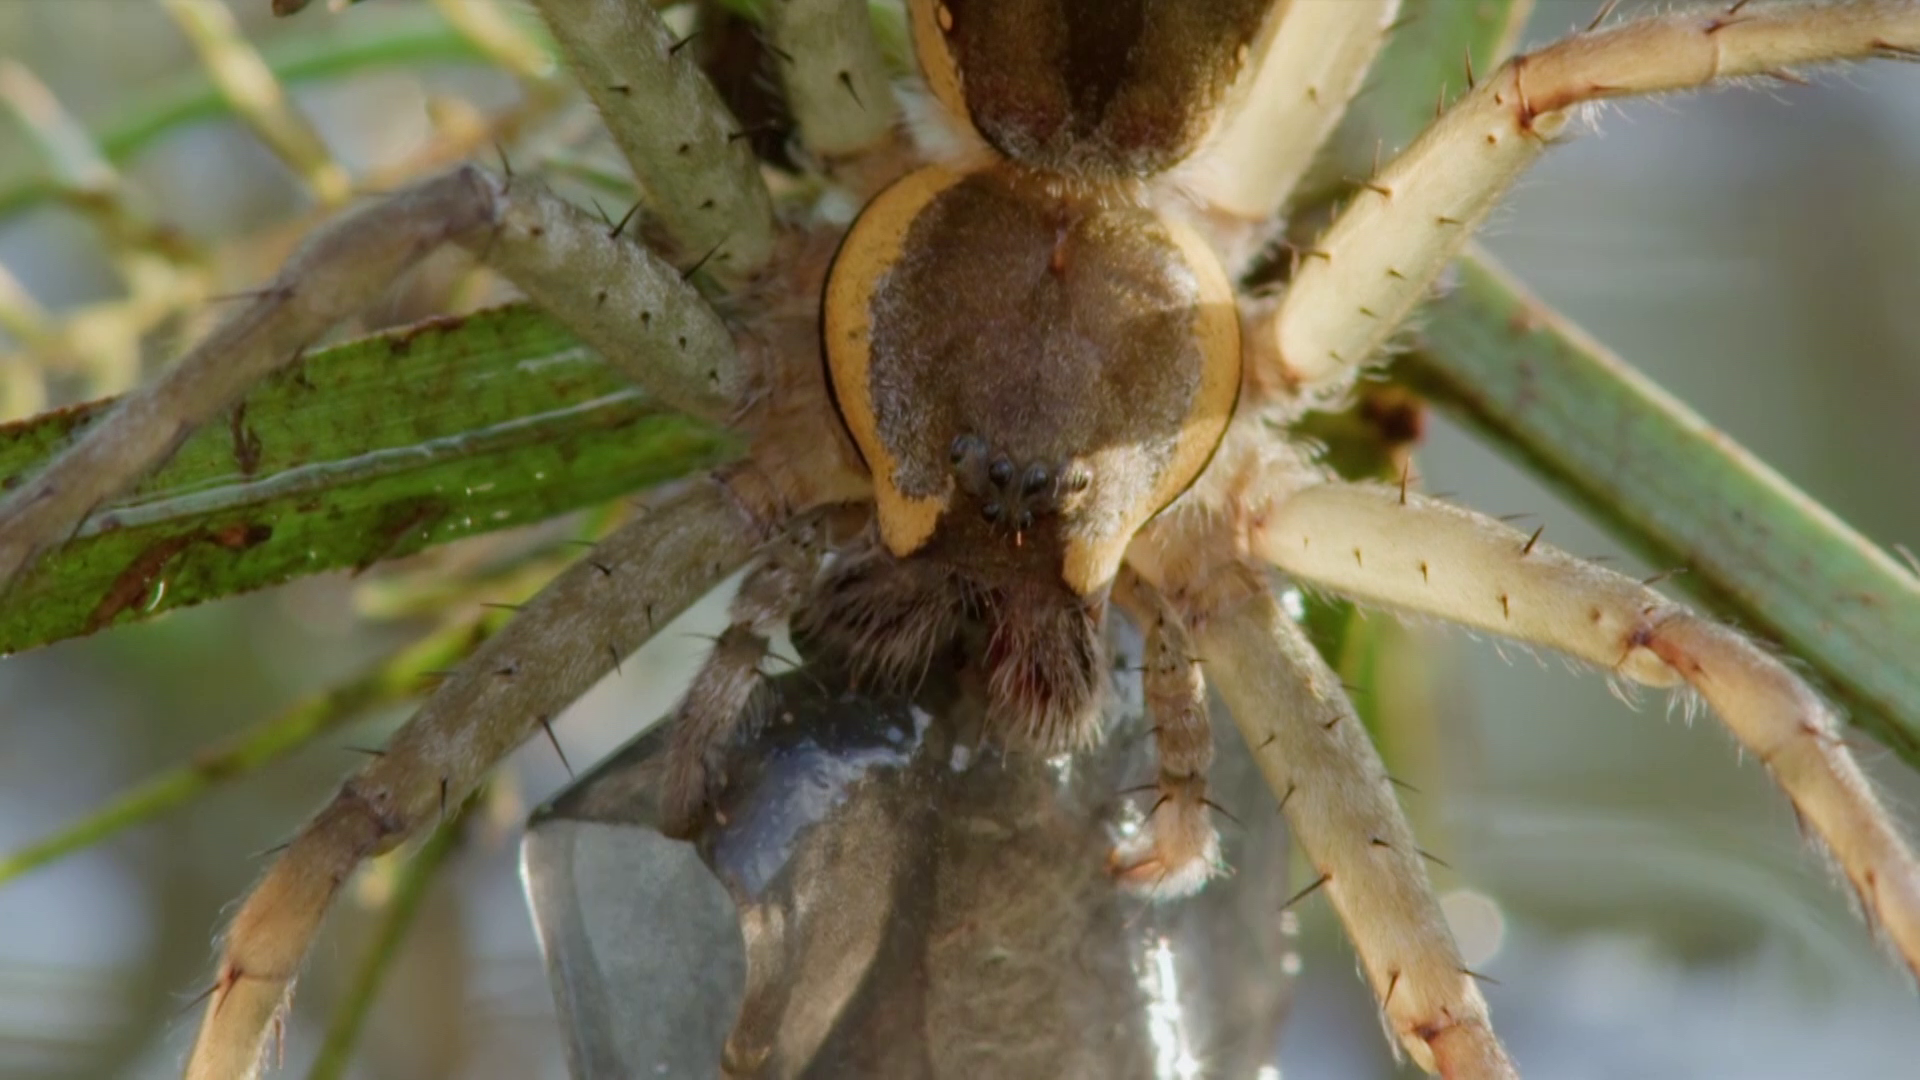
[822,165,964,557]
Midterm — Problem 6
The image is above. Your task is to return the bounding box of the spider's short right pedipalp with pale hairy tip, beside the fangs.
[1110,571,1223,899]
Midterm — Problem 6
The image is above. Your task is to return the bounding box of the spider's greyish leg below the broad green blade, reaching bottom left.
[186,480,770,1080]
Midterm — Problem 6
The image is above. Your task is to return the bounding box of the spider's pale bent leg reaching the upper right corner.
[1248,0,1920,400]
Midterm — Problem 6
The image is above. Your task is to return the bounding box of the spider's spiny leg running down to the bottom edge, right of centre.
[1188,569,1515,1080]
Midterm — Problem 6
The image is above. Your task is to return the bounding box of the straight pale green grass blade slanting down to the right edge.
[1396,256,1920,765]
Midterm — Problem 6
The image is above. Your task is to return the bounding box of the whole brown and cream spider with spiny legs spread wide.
[0,0,1920,1078]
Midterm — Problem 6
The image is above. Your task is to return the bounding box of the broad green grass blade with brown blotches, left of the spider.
[0,306,737,651]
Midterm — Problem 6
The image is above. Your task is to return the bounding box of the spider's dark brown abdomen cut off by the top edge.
[912,0,1275,175]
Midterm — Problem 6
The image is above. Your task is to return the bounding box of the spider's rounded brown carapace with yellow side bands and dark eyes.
[824,165,1240,598]
